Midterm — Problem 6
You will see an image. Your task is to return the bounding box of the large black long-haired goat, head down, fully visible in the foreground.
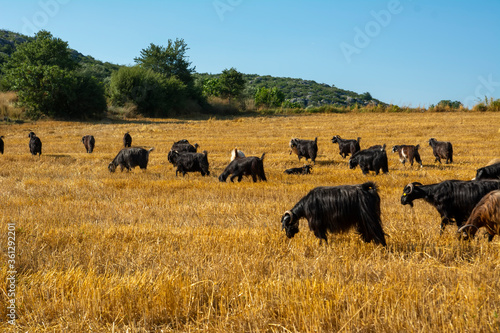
[281,182,386,246]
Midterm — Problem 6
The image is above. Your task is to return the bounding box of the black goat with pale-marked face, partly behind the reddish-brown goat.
[401,180,500,233]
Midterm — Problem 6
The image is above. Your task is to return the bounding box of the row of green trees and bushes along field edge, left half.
[0,30,254,119]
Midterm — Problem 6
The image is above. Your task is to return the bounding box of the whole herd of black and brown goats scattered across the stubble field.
[0,132,500,246]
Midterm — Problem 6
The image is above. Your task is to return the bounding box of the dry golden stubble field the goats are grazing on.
[0,113,500,332]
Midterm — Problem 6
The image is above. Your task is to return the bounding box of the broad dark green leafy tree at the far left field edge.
[2,30,106,119]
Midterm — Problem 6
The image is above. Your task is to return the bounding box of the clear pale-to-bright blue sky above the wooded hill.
[0,0,500,106]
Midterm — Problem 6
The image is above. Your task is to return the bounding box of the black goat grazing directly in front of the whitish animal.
[219,153,267,183]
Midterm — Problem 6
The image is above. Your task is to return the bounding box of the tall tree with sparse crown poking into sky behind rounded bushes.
[134,39,195,85]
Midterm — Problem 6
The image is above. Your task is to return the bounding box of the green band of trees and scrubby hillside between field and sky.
[0,30,500,119]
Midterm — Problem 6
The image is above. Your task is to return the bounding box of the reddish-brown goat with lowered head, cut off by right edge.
[458,190,500,242]
